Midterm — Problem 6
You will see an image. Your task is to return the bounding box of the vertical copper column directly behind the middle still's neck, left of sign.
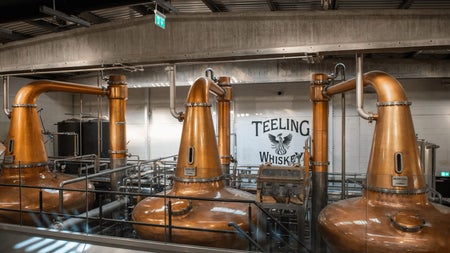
[217,77,233,185]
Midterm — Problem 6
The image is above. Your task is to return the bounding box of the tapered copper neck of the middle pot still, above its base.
[174,77,225,191]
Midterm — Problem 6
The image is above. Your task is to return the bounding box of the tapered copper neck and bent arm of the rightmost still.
[326,71,426,194]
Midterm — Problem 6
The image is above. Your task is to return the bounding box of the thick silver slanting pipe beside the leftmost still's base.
[50,197,128,230]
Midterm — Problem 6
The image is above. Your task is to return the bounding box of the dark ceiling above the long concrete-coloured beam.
[0,0,450,44]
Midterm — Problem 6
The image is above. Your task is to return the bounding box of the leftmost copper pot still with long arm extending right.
[0,81,106,226]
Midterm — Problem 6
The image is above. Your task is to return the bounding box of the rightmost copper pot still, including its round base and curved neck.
[319,71,450,253]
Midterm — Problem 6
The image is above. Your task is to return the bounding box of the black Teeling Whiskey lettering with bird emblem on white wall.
[252,118,309,165]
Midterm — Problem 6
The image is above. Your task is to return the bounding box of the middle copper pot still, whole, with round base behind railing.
[132,78,256,249]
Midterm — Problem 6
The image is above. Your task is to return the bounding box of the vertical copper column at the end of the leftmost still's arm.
[108,75,128,191]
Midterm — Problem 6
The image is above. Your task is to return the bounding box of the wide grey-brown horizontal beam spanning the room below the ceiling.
[0,10,450,73]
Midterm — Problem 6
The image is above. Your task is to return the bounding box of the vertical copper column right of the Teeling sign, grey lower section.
[311,74,329,252]
